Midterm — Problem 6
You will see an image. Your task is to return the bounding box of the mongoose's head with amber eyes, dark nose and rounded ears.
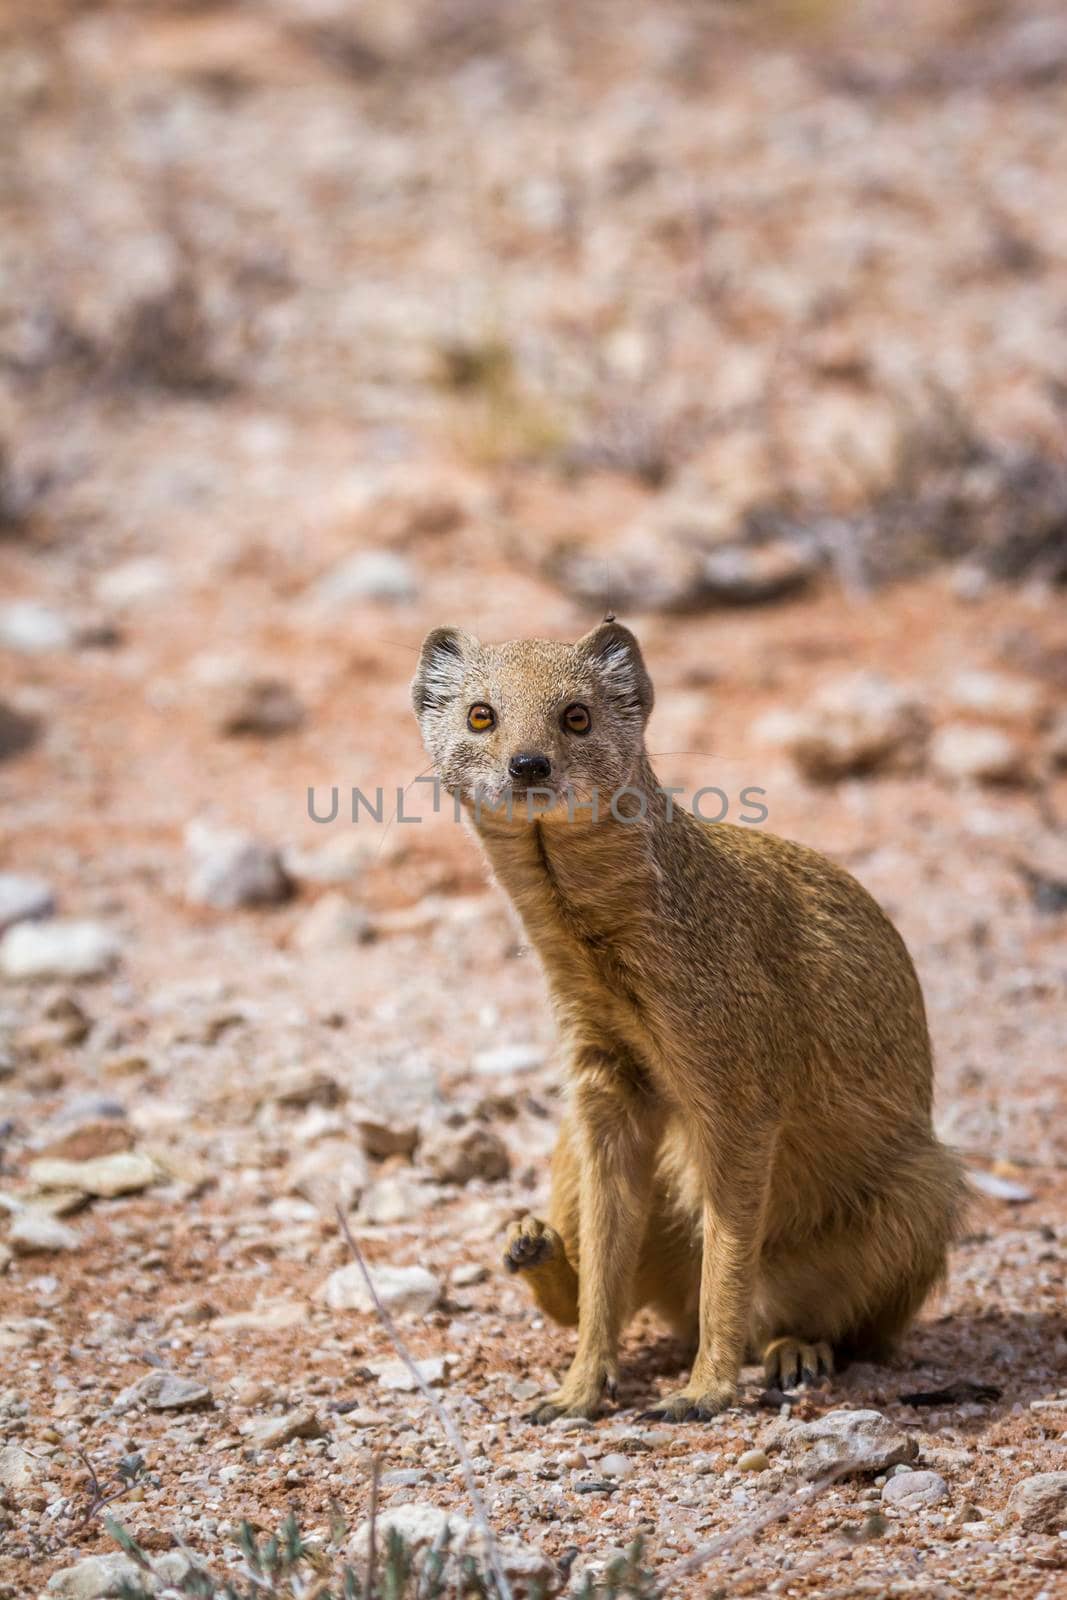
[411,621,653,819]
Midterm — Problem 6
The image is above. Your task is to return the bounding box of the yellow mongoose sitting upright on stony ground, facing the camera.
[413,621,965,1421]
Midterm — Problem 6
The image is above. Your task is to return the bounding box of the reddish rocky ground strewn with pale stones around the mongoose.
[0,0,1067,1600]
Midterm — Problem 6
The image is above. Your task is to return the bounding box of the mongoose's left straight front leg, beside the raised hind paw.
[531,1050,659,1422]
